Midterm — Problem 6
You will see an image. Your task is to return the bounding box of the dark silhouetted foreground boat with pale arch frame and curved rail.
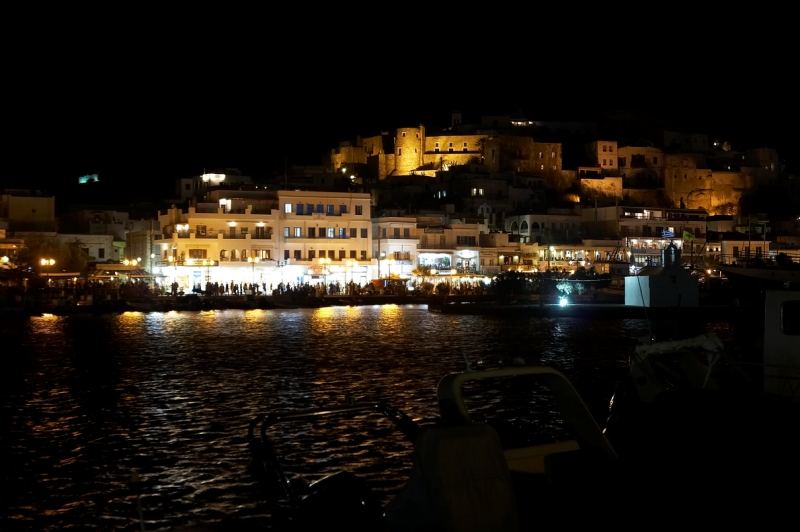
[249,367,617,531]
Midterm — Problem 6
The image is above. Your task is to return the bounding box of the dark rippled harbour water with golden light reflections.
[0,305,736,530]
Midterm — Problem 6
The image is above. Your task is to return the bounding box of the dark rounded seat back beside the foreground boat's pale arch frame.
[387,424,519,532]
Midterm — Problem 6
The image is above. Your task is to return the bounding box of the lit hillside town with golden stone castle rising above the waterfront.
[0,112,800,312]
